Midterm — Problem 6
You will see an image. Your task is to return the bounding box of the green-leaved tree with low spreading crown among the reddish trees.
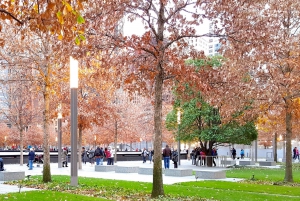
[166,86,257,166]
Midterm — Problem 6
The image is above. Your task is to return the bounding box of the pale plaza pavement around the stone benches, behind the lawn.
[0,160,278,194]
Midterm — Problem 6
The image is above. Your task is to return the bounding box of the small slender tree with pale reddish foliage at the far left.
[1,70,39,166]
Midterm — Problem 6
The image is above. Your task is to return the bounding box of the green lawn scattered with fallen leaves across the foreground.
[0,165,300,201]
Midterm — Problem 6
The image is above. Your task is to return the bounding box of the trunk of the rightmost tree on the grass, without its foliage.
[284,99,293,182]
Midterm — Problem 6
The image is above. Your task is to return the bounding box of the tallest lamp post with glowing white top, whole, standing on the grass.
[70,57,78,186]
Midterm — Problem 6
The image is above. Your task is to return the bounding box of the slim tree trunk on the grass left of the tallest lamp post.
[43,79,51,183]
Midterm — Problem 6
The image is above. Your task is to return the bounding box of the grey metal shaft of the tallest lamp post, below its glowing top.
[71,88,78,186]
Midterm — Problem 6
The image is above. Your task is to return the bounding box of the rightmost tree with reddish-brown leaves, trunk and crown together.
[205,0,300,182]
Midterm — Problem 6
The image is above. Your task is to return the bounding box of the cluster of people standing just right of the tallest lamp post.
[81,146,115,165]
